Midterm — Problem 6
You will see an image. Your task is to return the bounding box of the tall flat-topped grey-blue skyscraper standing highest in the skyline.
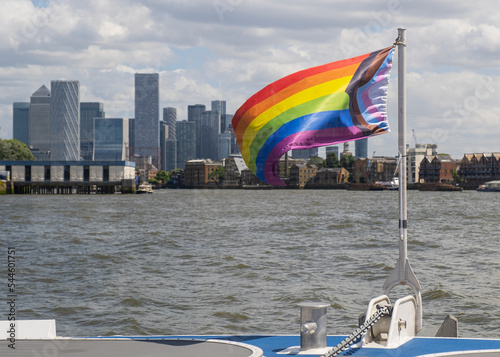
[133,73,160,168]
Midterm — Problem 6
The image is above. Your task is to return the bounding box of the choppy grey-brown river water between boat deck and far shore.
[0,190,500,337]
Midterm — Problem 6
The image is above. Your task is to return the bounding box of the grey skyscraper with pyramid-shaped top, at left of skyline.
[29,85,51,160]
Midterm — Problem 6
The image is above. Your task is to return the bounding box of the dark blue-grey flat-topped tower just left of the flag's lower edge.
[199,110,220,161]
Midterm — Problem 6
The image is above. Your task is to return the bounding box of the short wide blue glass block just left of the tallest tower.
[93,118,129,161]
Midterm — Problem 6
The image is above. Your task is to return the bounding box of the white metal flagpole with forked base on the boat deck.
[384,28,422,333]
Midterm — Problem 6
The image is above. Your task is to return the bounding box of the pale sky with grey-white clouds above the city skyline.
[0,0,500,158]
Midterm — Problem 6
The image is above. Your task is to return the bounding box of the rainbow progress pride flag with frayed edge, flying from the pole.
[232,46,394,186]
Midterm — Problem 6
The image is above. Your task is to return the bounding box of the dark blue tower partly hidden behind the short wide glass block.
[80,102,104,160]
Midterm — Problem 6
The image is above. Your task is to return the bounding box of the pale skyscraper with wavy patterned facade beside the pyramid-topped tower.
[50,81,80,161]
